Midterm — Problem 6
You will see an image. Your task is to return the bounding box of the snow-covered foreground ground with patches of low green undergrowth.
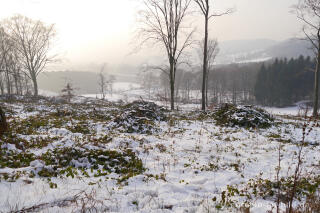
[0,95,320,213]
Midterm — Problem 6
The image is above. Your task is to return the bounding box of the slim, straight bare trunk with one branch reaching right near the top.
[194,0,233,110]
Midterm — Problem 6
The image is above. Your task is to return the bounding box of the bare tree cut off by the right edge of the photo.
[294,0,320,117]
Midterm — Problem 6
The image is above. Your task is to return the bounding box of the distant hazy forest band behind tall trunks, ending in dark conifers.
[140,56,315,107]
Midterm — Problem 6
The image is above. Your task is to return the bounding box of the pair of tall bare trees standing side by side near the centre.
[138,0,231,110]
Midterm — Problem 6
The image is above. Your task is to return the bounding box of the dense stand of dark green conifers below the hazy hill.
[254,56,316,106]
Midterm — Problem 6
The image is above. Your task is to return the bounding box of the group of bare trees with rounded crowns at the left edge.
[0,15,56,96]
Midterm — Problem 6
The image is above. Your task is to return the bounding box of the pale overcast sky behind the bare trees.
[0,0,301,68]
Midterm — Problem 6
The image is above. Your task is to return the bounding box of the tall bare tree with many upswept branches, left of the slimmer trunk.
[138,0,194,110]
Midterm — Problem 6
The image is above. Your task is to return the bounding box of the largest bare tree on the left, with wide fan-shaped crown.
[5,15,56,96]
